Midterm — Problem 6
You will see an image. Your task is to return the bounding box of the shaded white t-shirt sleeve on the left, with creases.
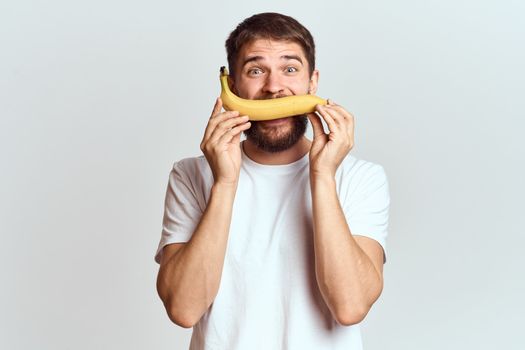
[155,162,203,264]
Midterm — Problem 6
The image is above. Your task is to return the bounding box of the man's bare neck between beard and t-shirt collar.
[242,136,311,165]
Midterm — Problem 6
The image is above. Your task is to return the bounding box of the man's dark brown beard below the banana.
[244,115,308,153]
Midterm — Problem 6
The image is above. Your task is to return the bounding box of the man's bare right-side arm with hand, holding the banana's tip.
[309,103,383,325]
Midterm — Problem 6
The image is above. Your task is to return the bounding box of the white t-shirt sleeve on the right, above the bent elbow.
[343,164,390,263]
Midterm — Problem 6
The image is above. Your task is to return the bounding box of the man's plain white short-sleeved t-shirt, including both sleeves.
[155,144,390,350]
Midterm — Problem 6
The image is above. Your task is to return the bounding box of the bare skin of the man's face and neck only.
[230,39,319,164]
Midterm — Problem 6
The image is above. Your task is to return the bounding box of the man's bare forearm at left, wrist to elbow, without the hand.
[160,185,235,325]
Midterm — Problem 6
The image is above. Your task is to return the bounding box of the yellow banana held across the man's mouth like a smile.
[220,67,327,120]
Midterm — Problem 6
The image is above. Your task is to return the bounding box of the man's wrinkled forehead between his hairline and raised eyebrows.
[238,39,306,62]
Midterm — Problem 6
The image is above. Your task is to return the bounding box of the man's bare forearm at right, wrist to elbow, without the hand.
[311,176,382,324]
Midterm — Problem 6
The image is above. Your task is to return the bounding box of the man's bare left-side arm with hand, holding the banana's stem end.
[157,99,250,328]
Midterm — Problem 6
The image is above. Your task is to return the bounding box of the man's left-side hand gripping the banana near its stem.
[200,98,251,186]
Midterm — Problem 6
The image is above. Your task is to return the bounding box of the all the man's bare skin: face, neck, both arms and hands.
[157,39,383,327]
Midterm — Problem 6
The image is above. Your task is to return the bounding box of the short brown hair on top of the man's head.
[226,12,315,76]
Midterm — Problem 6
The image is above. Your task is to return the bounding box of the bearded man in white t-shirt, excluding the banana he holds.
[155,13,389,350]
